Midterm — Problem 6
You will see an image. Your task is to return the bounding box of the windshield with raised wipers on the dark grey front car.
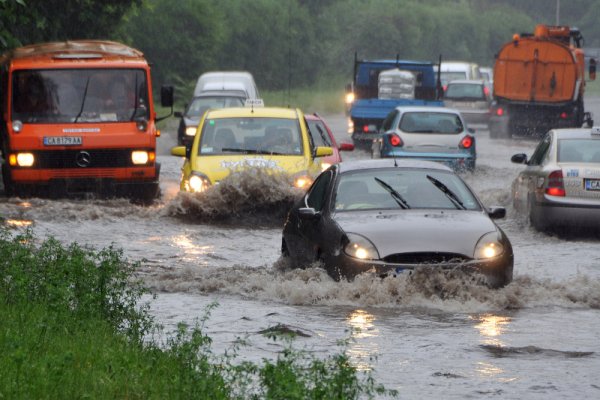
[334,168,481,211]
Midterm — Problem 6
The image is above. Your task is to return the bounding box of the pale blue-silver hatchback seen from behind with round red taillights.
[372,107,477,171]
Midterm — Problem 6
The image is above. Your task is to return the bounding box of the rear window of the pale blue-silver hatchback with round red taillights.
[398,111,464,134]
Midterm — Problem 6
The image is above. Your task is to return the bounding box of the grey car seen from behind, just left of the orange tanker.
[444,80,492,125]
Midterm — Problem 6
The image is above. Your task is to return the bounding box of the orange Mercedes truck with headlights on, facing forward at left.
[0,40,173,202]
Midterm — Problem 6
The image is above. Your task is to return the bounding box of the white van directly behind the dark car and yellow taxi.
[194,71,260,99]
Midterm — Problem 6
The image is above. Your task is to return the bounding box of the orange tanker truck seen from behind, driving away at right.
[489,25,596,138]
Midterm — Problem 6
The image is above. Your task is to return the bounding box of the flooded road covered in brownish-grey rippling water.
[0,99,600,399]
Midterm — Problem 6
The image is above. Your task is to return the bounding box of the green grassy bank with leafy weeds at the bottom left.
[0,230,394,399]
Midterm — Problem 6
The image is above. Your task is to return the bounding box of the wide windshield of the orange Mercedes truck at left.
[11,69,149,123]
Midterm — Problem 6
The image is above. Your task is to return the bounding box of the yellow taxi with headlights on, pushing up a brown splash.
[171,107,333,192]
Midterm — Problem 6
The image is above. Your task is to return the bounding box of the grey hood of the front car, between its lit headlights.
[334,210,497,258]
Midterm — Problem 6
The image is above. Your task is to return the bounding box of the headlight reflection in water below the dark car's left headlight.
[346,309,380,371]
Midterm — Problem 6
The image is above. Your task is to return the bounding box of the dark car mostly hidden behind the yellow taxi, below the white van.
[175,90,246,145]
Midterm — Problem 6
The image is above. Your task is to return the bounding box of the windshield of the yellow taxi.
[199,117,302,155]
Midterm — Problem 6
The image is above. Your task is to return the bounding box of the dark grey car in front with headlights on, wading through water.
[282,159,513,287]
